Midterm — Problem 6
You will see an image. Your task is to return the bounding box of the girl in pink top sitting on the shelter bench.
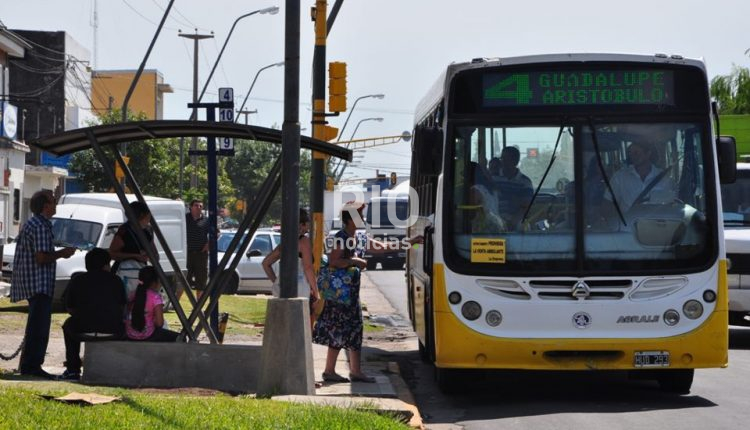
[125,266,180,342]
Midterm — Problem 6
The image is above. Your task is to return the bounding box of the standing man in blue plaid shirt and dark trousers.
[10,190,76,379]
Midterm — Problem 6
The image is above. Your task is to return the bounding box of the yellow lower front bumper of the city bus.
[434,262,729,370]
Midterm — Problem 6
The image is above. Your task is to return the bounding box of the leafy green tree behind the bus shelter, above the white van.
[70,109,234,204]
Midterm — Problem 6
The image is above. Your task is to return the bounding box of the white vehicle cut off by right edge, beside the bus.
[721,163,750,325]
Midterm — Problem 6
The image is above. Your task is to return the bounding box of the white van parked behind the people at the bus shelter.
[3,193,187,303]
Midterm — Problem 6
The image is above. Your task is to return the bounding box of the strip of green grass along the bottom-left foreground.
[0,383,408,430]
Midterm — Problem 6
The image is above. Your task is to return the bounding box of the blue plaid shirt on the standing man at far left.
[10,214,57,302]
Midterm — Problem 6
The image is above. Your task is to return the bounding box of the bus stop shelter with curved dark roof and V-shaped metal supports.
[30,120,352,343]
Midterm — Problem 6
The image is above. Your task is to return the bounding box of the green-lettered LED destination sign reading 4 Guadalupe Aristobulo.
[482,70,674,107]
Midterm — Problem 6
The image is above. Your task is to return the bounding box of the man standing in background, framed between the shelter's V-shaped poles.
[185,200,209,298]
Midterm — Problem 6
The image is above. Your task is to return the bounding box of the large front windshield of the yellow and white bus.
[444,117,716,275]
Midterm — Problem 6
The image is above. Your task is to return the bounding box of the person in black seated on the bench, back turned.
[60,248,127,381]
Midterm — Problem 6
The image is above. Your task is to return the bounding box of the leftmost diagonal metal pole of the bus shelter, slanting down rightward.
[86,131,200,340]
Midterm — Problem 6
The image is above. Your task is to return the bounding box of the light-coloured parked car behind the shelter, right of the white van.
[217,229,281,294]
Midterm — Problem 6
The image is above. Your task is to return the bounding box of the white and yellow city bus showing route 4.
[407,54,736,393]
